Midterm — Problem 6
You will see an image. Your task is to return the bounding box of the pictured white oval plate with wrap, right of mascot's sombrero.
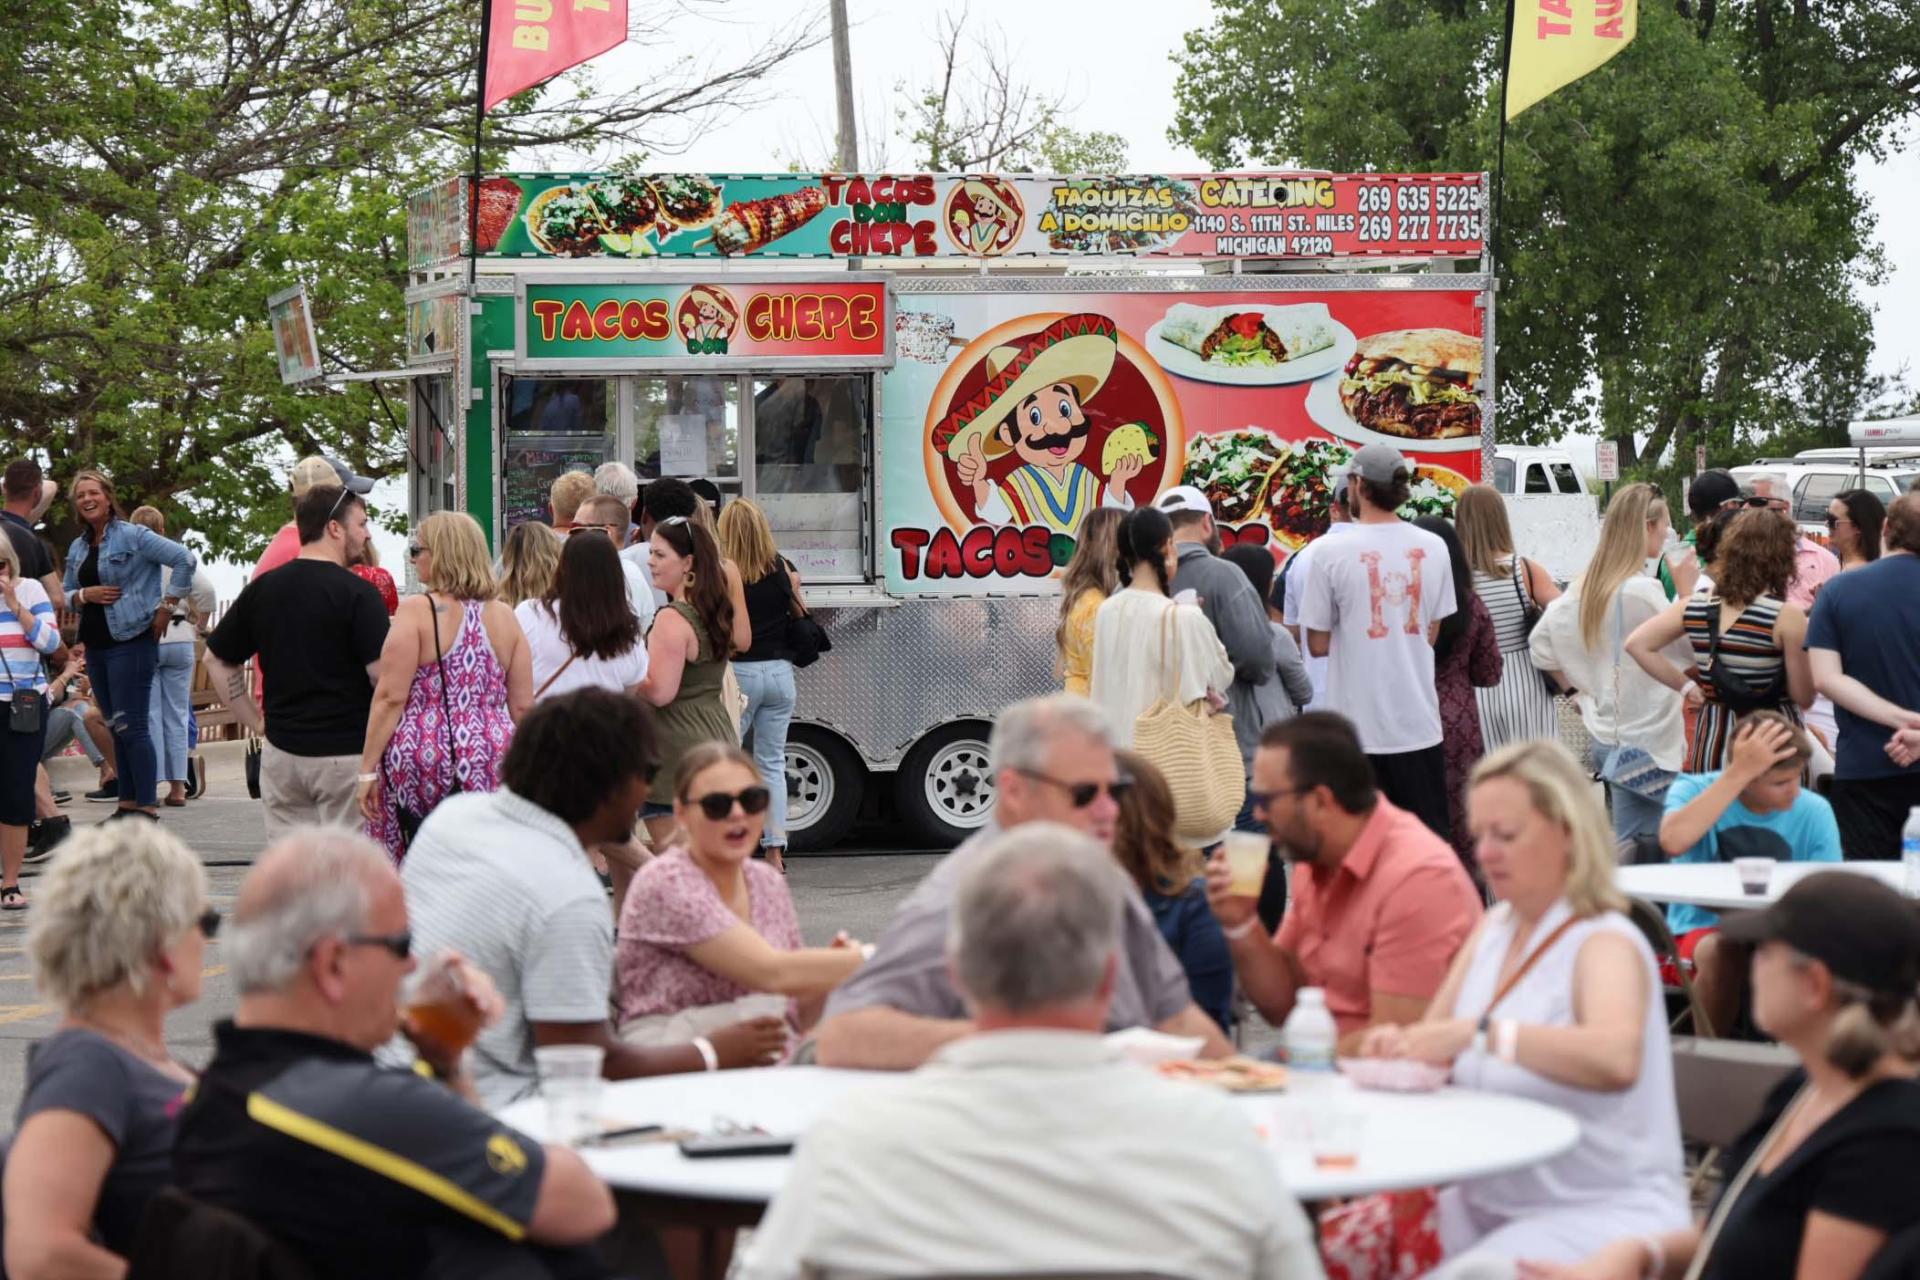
[1146,301,1354,386]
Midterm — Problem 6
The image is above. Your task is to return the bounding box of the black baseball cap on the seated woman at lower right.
[1720,871,1920,996]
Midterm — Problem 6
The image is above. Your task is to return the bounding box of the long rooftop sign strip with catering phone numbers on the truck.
[460,173,1486,259]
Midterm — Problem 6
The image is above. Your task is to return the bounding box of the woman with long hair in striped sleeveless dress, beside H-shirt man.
[1453,484,1559,754]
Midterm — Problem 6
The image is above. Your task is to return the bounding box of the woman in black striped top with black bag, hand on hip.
[1626,510,1814,773]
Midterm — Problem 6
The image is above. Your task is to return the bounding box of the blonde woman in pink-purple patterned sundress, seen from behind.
[359,510,534,864]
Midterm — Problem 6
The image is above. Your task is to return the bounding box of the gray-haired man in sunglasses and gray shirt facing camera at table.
[818,693,1233,1071]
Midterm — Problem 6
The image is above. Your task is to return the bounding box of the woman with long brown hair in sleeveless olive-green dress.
[639,516,739,846]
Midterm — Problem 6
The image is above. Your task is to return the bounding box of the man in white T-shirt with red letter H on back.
[1300,445,1453,837]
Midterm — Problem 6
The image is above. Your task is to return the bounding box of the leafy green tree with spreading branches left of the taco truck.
[0,0,818,555]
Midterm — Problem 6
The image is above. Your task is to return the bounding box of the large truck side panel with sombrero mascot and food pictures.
[879,288,1486,595]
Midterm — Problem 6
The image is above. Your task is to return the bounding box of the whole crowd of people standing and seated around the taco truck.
[0,445,1920,1280]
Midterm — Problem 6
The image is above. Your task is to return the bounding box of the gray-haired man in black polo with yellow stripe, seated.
[173,827,614,1280]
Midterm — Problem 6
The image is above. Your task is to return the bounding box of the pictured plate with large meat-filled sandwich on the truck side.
[1308,328,1482,453]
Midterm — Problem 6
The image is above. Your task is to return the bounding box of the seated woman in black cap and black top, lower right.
[1521,871,1920,1280]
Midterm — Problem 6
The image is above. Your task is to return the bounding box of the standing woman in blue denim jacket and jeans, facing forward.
[65,468,196,818]
